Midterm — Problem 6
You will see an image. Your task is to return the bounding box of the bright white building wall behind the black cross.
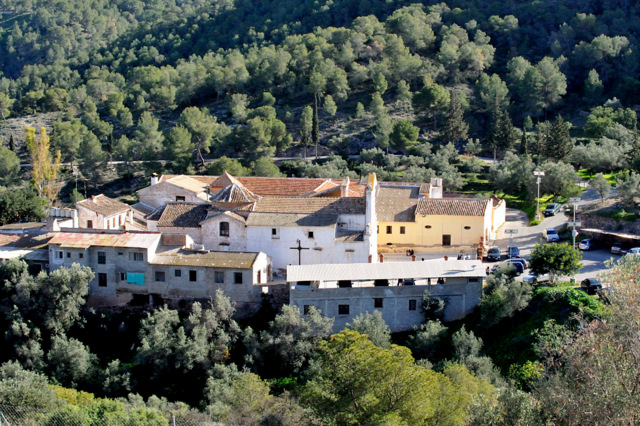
[247,226,369,269]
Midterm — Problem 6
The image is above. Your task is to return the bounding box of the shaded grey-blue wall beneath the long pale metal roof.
[290,278,482,332]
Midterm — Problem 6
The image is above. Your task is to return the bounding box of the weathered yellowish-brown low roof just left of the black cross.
[149,249,260,269]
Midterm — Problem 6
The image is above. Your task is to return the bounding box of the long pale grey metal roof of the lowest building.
[287,260,486,282]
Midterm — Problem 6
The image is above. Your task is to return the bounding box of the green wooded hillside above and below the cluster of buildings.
[0,0,640,425]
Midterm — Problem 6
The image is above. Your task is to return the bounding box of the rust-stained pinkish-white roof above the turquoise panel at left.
[49,232,160,248]
